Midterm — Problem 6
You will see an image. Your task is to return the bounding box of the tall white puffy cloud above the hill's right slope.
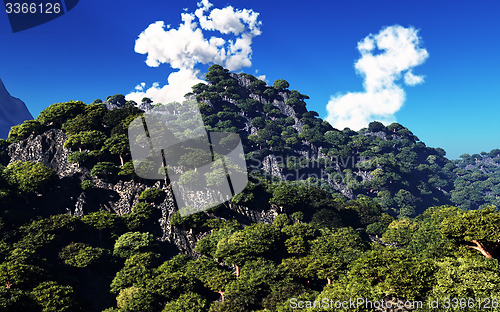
[327,25,429,130]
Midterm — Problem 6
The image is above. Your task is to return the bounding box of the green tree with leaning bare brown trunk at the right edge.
[441,207,500,258]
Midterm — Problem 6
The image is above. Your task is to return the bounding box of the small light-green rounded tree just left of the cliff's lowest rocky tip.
[113,232,153,258]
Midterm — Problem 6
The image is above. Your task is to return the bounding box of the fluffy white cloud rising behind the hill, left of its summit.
[126,0,261,103]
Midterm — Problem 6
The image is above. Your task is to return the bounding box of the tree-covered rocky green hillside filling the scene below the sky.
[0,65,500,312]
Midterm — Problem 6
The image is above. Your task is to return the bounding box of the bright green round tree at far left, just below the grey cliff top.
[6,160,57,193]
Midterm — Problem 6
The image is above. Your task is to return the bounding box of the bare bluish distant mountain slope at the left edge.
[0,79,33,139]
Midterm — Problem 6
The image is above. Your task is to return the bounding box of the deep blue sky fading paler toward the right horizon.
[0,0,500,158]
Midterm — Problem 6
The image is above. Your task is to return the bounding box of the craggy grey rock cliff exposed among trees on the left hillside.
[8,125,277,256]
